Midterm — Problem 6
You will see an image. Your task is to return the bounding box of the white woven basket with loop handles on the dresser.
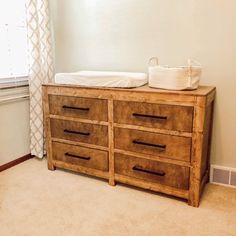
[148,57,202,90]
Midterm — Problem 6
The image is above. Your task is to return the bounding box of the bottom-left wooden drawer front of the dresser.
[52,142,108,171]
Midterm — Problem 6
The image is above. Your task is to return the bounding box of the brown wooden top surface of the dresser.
[43,83,216,96]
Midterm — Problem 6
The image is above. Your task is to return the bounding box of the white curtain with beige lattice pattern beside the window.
[26,0,53,158]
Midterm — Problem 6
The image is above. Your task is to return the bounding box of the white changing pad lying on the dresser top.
[55,71,148,88]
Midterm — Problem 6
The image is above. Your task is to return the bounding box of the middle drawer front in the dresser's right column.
[115,128,191,161]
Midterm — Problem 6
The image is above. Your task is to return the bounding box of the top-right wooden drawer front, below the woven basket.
[114,101,193,132]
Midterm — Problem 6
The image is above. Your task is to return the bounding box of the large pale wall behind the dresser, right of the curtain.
[50,0,236,167]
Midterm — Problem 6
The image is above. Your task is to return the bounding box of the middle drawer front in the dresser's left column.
[51,119,108,147]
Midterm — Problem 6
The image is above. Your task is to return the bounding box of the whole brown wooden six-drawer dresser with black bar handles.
[43,84,215,207]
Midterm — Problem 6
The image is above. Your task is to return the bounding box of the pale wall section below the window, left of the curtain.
[0,99,30,165]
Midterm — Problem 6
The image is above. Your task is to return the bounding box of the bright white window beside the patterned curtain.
[0,0,28,86]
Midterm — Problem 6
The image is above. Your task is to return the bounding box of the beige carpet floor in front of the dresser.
[0,159,236,236]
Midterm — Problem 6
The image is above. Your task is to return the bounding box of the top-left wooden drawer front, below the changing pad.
[49,95,108,121]
